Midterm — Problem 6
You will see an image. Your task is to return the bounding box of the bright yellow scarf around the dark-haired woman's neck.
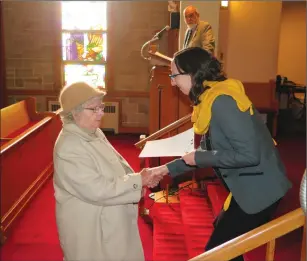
[191,79,254,135]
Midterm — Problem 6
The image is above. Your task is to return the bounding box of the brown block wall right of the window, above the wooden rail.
[110,1,169,91]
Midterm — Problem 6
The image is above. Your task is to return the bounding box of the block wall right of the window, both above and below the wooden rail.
[108,1,169,128]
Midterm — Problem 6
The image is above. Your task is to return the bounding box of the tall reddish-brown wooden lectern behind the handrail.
[141,30,192,197]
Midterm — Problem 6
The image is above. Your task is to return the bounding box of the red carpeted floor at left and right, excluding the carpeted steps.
[1,135,306,261]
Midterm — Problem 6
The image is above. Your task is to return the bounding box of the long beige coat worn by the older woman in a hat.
[54,123,144,261]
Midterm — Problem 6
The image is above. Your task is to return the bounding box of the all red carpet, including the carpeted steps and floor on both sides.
[1,135,306,261]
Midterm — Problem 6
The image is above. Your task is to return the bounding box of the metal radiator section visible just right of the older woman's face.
[100,102,119,133]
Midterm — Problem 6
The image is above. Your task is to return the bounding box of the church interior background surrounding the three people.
[0,1,306,261]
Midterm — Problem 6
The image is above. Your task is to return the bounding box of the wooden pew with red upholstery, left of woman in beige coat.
[0,98,62,243]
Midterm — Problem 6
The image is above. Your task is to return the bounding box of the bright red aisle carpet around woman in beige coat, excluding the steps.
[1,136,153,261]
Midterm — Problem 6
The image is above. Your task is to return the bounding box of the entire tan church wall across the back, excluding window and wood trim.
[3,1,306,130]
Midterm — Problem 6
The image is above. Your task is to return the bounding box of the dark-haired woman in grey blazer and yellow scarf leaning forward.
[153,47,291,261]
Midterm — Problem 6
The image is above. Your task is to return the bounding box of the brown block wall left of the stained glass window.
[3,1,60,91]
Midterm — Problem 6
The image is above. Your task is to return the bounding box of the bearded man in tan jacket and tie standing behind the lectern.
[183,5,215,54]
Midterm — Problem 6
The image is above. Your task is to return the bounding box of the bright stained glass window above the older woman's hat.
[62,1,107,87]
